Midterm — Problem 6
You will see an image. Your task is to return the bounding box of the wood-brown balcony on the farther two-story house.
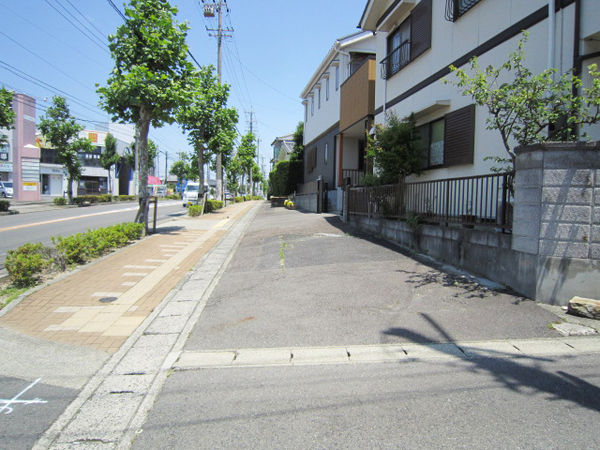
[340,58,376,131]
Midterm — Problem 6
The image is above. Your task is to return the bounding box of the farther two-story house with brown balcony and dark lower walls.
[300,31,375,212]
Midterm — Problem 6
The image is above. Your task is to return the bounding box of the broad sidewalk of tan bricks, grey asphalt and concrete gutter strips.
[0,202,600,449]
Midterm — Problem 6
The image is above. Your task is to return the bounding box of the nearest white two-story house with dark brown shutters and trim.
[359,0,600,181]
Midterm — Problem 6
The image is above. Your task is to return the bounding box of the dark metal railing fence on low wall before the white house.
[348,173,513,233]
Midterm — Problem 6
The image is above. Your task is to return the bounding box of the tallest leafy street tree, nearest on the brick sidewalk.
[98,0,197,222]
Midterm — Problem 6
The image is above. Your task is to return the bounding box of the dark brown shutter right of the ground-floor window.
[444,105,475,166]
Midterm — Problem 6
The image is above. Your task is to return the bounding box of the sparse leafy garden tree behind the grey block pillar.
[446,32,600,171]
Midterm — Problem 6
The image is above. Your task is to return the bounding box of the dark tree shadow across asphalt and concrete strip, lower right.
[383,314,600,412]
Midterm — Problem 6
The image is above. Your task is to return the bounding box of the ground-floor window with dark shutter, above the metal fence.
[418,105,475,169]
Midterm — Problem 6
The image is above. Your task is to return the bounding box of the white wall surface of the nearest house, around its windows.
[375,0,600,180]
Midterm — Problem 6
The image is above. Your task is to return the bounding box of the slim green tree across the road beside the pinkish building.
[38,97,93,203]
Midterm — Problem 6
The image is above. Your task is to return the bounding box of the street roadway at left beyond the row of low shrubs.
[0,200,186,275]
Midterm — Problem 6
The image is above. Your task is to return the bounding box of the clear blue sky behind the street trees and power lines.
[0,0,367,178]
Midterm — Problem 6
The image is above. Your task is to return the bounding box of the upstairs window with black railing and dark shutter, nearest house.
[381,0,432,79]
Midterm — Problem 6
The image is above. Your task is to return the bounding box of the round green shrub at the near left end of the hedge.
[4,243,48,287]
